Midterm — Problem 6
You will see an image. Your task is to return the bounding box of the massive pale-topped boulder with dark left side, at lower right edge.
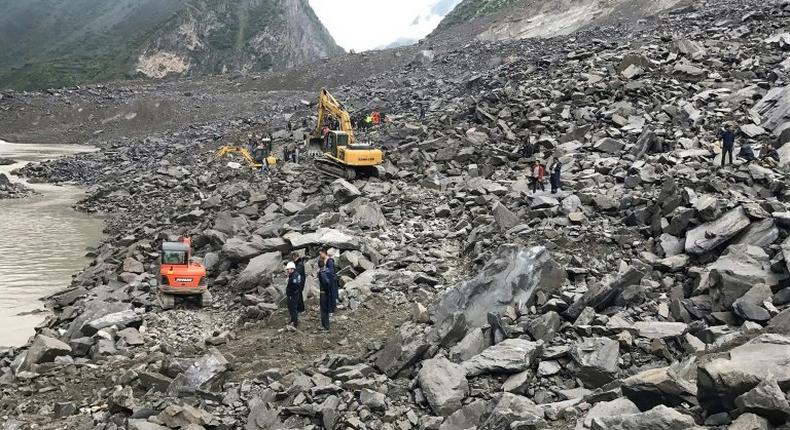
[697,334,790,413]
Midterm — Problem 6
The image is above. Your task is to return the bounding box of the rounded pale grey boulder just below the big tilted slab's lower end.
[417,357,469,416]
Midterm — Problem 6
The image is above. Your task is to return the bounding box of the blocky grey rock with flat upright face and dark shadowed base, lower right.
[571,337,620,388]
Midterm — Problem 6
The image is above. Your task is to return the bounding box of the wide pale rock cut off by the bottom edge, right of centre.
[592,405,697,430]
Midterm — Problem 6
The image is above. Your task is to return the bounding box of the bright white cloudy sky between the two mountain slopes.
[310,0,461,52]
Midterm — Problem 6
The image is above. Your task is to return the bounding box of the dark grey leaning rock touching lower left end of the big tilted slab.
[376,322,430,377]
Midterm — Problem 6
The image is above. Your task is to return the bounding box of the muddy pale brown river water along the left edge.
[0,140,103,346]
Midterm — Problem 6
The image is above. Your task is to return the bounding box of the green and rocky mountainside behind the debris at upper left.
[0,0,343,89]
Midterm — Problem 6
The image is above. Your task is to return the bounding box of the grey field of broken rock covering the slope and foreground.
[0,0,790,430]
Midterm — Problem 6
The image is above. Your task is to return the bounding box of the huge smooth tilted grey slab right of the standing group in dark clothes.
[431,245,565,329]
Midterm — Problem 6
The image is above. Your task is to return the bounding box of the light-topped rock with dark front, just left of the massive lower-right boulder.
[621,367,697,411]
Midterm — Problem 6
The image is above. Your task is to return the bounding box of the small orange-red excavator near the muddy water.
[159,237,211,309]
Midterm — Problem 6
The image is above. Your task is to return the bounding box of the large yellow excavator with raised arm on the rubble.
[305,88,384,180]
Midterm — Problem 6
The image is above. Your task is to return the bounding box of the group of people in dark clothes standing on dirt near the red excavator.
[285,247,339,330]
